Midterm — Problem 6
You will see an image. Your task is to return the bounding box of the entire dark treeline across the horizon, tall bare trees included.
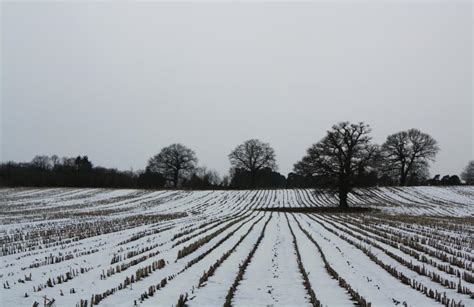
[0,122,474,192]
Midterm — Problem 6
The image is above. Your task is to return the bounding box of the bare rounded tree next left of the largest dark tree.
[229,139,278,188]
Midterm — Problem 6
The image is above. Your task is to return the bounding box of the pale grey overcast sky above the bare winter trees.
[0,1,474,178]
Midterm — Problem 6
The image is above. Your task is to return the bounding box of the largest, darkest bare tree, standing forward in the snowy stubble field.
[294,122,377,208]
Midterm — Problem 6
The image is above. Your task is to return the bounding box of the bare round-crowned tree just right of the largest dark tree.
[382,129,439,186]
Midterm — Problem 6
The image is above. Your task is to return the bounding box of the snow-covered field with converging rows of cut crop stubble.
[0,187,474,307]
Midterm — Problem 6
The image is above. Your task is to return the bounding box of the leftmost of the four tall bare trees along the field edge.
[148,144,197,187]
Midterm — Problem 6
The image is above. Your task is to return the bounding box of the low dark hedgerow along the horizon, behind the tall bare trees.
[0,155,464,190]
